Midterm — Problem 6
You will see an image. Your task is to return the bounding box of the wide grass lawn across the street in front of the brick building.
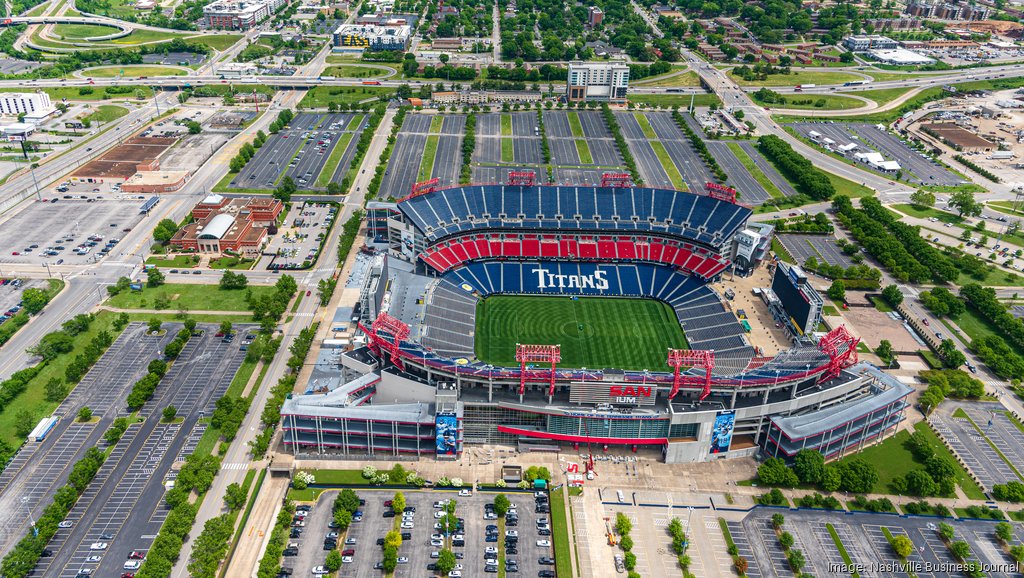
[106,283,274,312]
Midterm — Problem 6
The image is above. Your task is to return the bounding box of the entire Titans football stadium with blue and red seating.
[282,175,911,462]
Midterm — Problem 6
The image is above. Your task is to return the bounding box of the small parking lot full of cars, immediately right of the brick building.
[264,202,338,269]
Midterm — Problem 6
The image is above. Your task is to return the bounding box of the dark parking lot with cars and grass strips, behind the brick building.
[228,113,366,191]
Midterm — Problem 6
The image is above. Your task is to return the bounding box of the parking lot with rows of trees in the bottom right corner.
[729,508,1020,578]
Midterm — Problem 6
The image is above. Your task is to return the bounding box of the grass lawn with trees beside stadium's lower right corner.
[843,421,985,500]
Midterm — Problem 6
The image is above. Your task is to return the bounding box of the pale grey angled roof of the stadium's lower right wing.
[772,363,913,440]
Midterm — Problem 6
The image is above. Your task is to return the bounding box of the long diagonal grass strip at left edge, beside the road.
[0,312,119,448]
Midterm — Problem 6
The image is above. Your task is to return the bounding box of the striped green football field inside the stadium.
[475,295,686,371]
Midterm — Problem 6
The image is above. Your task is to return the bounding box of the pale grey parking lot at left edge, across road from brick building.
[0,198,143,264]
